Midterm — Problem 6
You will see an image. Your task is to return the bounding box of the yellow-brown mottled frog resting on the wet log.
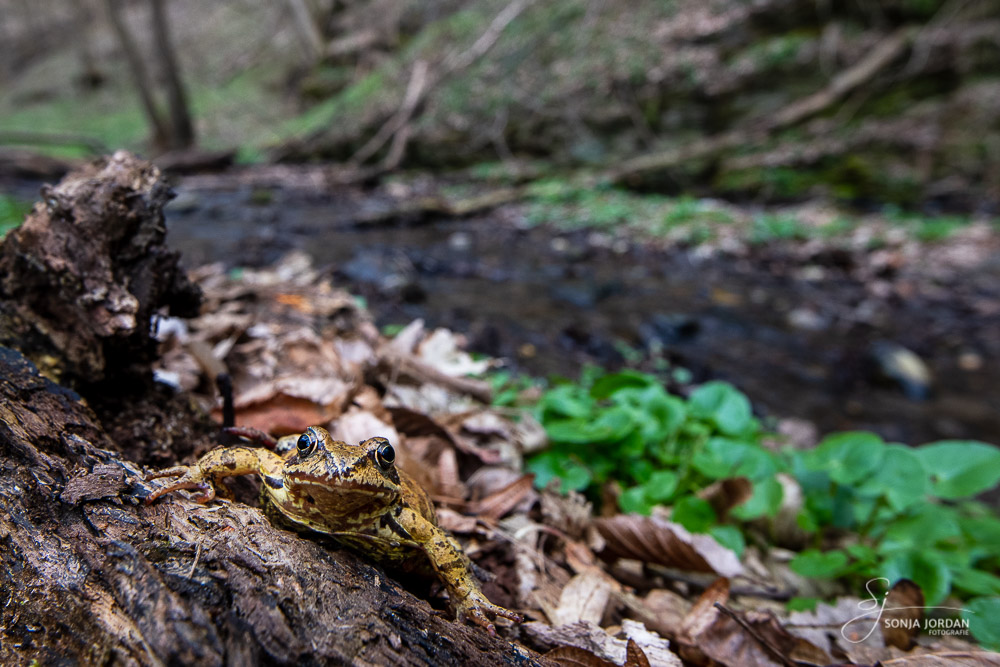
[146,426,522,636]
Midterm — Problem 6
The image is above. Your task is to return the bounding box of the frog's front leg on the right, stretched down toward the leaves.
[401,508,521,636]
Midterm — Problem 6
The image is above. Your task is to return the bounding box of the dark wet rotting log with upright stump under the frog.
[0,154,537,665]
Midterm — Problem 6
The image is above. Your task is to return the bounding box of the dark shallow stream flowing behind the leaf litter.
[160,182,1000,443]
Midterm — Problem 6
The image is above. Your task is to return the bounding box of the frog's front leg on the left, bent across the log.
[146,447,283,504]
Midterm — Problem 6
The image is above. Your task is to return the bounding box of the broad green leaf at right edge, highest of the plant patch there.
[915,440,1000,500]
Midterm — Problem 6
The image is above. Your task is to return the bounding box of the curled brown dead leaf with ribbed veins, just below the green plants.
[594,514,743,577]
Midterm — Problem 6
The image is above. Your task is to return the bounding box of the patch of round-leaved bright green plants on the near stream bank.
[527,370,1000,647]
